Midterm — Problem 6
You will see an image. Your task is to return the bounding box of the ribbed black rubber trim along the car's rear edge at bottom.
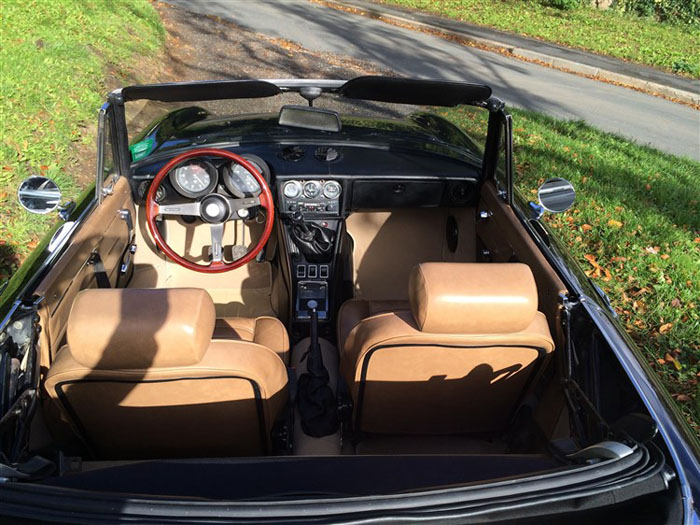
[0,444,664,523]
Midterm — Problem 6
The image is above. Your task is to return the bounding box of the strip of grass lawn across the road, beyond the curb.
[379,0,700,78]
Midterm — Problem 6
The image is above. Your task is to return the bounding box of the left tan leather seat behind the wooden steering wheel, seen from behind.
[45,288,287,459]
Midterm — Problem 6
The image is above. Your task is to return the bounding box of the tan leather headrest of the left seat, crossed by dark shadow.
[67,288,216,370]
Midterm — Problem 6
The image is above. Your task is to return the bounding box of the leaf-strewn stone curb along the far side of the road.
[322,0,700,106]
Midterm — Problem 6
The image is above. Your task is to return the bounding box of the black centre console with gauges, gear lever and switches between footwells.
[277,179,344,328]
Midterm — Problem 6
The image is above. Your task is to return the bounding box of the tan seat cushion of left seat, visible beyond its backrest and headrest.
[213,316,289,365]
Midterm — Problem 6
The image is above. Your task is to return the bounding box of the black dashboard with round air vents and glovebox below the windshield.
[131,143,479,218]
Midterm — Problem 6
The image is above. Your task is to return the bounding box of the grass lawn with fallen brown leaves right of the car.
[442,104,700,430]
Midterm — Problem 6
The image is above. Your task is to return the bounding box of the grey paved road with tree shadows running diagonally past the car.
[169,0,700,160]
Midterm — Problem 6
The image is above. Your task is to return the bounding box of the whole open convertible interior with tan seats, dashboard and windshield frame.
[3,77,688,519]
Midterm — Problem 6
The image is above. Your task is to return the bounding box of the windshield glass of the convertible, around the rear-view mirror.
[126,93,485,163]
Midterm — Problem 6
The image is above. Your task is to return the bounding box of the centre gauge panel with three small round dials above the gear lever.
[280,180,343,215]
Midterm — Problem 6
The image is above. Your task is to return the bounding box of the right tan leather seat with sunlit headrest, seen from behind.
[338,263,554,435]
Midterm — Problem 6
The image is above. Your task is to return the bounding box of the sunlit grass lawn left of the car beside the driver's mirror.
[0,0,165,281]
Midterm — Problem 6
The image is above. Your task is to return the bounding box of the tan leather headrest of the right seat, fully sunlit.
[408,263,537,334]
